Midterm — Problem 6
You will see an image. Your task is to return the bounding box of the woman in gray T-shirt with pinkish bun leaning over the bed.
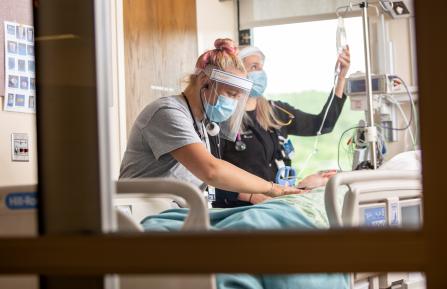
[120,39,300,197]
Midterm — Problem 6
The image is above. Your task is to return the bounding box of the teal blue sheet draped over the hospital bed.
[141,200,349,289]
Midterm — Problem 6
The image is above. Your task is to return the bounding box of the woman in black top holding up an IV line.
[212,47,350,208]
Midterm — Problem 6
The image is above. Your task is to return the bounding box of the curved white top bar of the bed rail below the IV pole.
[324,170,422,228]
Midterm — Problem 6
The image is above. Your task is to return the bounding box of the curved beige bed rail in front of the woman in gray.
[116,178,210,231]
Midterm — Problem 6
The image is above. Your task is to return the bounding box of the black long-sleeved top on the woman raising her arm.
[210,94,346,208]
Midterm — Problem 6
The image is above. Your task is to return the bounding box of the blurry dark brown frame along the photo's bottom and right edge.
[0,1,447,289]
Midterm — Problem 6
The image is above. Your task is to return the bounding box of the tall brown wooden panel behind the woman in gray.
[123,0,197,133]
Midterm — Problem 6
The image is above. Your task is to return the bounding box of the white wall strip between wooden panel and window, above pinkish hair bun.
[196,0,237,54]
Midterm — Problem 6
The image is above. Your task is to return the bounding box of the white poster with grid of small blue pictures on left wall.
[4,21,36,113]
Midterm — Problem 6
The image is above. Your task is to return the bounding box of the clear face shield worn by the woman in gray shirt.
[203,68,253,141]
